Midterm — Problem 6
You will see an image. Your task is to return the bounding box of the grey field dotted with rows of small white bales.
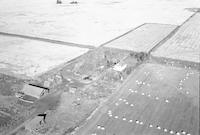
[75,63,199,135]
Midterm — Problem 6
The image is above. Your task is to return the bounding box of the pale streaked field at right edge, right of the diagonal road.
[152,13,200,63]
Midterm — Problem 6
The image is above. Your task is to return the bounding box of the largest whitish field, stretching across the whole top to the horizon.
[0,0,200,46]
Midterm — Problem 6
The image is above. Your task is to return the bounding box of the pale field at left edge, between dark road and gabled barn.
[0,36,88,78]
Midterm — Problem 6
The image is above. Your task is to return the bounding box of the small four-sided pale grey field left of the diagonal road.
[105,24,177,53]
